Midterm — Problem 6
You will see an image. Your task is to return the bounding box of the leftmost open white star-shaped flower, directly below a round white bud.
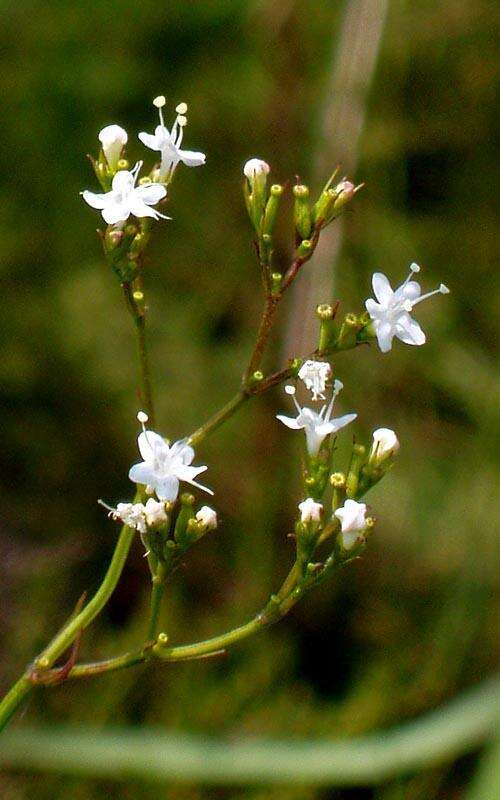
[82,161,169,225]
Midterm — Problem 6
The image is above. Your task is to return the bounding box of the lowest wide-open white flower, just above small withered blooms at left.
[128,428,213,500]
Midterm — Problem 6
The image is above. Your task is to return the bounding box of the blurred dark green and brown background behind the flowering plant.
[0,0,500,800]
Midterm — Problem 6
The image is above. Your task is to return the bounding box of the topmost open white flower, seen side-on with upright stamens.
[139,95,205,183]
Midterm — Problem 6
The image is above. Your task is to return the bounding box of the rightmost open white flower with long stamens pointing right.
[365,264,450,353]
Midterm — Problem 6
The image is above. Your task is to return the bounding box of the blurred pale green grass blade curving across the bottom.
[0,677,500,786]
